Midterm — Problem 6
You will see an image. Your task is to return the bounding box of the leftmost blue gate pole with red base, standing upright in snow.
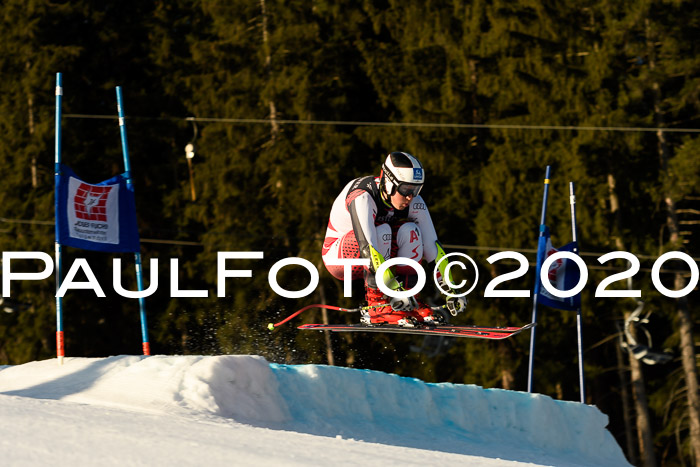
[54,73,66,365]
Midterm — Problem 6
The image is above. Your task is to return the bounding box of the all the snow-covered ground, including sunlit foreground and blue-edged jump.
[0,356,629,467]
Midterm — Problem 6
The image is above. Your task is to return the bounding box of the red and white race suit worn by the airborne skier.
[322,176,438,280]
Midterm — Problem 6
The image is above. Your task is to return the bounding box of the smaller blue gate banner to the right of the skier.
[535,227,581,310]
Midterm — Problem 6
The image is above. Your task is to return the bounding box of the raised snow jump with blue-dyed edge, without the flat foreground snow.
[0,355,629,466]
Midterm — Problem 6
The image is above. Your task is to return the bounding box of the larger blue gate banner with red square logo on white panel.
[56,164,141,253]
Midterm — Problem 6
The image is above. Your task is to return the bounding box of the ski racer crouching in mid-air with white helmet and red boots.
[322,152,467,327]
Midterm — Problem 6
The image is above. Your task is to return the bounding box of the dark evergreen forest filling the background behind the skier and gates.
[0,0,700,465]
